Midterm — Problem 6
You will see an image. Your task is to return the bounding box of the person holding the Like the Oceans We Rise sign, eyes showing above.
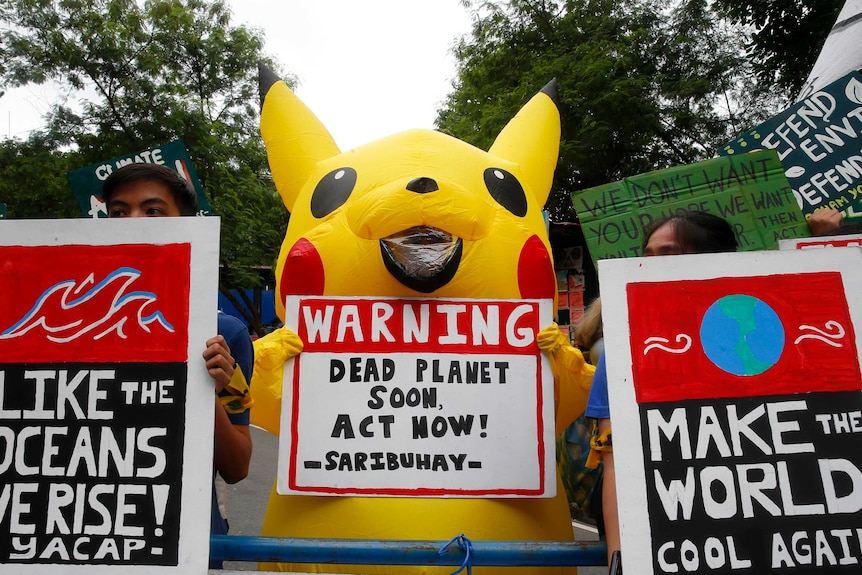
[102,164,254,552]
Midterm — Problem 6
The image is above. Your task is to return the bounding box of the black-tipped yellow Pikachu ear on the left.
[258,63,341,212]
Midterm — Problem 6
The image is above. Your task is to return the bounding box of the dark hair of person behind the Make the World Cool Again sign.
[642,210,739,254]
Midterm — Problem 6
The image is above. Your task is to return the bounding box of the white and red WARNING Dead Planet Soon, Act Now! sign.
[278,296,556,497]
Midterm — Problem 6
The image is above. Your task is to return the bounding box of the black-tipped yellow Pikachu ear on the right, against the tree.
[488,79,560,206]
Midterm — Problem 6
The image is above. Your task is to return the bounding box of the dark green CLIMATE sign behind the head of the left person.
[66,140,212,218]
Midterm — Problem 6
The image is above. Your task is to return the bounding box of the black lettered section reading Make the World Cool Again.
[639,392,862,575]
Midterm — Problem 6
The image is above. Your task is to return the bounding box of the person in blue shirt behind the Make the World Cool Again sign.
[586,211,738,562]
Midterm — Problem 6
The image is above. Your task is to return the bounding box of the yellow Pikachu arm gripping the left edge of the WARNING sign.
[251,328,302,435]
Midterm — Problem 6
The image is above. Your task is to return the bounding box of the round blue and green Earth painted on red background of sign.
[700,294,784,376]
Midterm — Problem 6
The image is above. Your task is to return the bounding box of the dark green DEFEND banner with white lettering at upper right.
[718,72,862,218]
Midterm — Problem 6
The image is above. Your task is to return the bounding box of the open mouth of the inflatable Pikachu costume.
[380,226,463,293]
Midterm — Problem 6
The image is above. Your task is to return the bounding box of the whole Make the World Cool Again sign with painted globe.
[599,250,862,575]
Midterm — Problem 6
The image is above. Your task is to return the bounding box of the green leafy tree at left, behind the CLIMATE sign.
[0,0,287,332]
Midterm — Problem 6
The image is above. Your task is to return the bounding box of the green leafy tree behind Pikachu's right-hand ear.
[437,0,772,220]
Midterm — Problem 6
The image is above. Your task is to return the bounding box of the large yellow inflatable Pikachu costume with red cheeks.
[252,67,593,574]
